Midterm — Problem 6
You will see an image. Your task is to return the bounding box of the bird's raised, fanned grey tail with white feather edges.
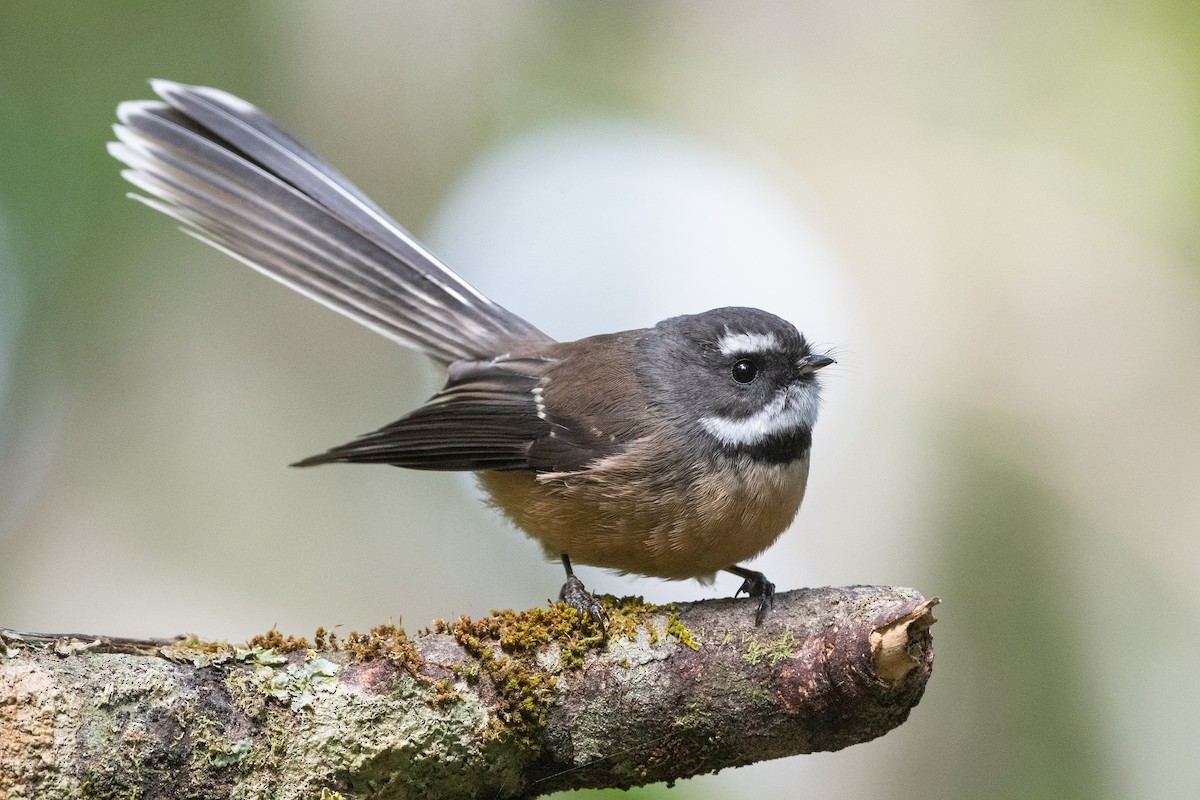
[109,80,550,363]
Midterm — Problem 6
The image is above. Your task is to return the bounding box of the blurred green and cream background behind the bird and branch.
[0,0,1200,800]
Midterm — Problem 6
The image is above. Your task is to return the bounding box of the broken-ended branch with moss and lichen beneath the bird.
[0,587,937,800]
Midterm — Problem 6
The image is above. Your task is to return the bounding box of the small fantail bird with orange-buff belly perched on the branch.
[108,80,834,627]
